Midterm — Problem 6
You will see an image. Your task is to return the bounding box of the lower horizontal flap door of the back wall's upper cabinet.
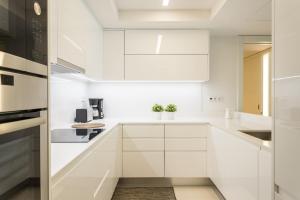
[125,55,209,81]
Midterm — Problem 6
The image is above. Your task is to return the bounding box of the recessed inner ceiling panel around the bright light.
[116,0,218,10]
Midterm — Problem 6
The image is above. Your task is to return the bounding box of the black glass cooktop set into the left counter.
[51,129,105,143]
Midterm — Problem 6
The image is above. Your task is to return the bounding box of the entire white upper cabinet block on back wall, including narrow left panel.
[103,30,209,81]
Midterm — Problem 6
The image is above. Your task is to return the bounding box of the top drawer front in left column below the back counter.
[123,125,164,138]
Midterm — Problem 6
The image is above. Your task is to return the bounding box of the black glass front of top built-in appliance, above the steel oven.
[0,0,48,67]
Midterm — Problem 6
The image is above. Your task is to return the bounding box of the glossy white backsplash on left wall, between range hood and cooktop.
[50,77,88,129]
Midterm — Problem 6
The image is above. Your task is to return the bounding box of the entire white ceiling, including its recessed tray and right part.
[85,0,272,35]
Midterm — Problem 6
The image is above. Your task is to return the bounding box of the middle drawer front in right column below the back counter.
[165,138,206,151]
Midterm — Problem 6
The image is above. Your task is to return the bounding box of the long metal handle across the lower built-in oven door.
[0,117,46,135]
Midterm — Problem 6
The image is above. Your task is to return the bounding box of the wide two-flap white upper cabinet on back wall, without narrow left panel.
[125,30,209,81]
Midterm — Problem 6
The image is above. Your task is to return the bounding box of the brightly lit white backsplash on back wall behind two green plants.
[89,83,202,118]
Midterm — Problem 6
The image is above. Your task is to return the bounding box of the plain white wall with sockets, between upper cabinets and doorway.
[202,36,238,112]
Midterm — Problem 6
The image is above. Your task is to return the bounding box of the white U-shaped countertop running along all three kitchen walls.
[51,118,271,177]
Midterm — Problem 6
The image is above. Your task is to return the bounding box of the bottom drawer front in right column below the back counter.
[165,152,207,178]
